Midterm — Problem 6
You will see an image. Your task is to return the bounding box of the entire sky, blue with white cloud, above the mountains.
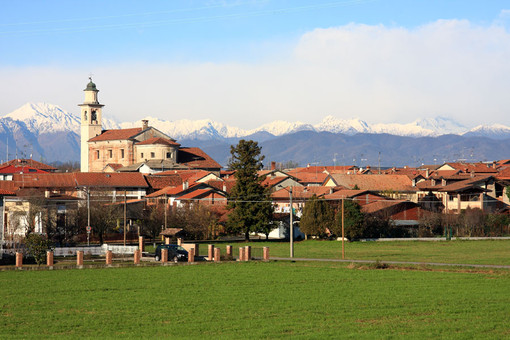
[0,0,510,129]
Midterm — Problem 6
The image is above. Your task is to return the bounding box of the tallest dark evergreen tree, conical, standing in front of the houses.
[227,139,273,240]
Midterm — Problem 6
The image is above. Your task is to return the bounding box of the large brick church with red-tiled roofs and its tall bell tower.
[79,78,221,174]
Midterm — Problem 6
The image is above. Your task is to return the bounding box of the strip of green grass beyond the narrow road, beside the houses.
[224,240,510,265]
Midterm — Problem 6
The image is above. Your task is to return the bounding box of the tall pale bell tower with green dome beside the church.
[78,77,104,172]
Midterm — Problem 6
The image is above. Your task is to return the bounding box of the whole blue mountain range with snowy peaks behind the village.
[0,103,510,166]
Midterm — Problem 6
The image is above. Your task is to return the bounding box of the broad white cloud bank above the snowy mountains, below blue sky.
[0,20,510,128]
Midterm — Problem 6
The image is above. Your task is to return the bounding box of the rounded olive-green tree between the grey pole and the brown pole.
[299,195,335,237]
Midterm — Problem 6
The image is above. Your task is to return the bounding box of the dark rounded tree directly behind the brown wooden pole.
[332,200,367,240]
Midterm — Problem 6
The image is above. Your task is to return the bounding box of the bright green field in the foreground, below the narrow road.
[0,261,510,339]
